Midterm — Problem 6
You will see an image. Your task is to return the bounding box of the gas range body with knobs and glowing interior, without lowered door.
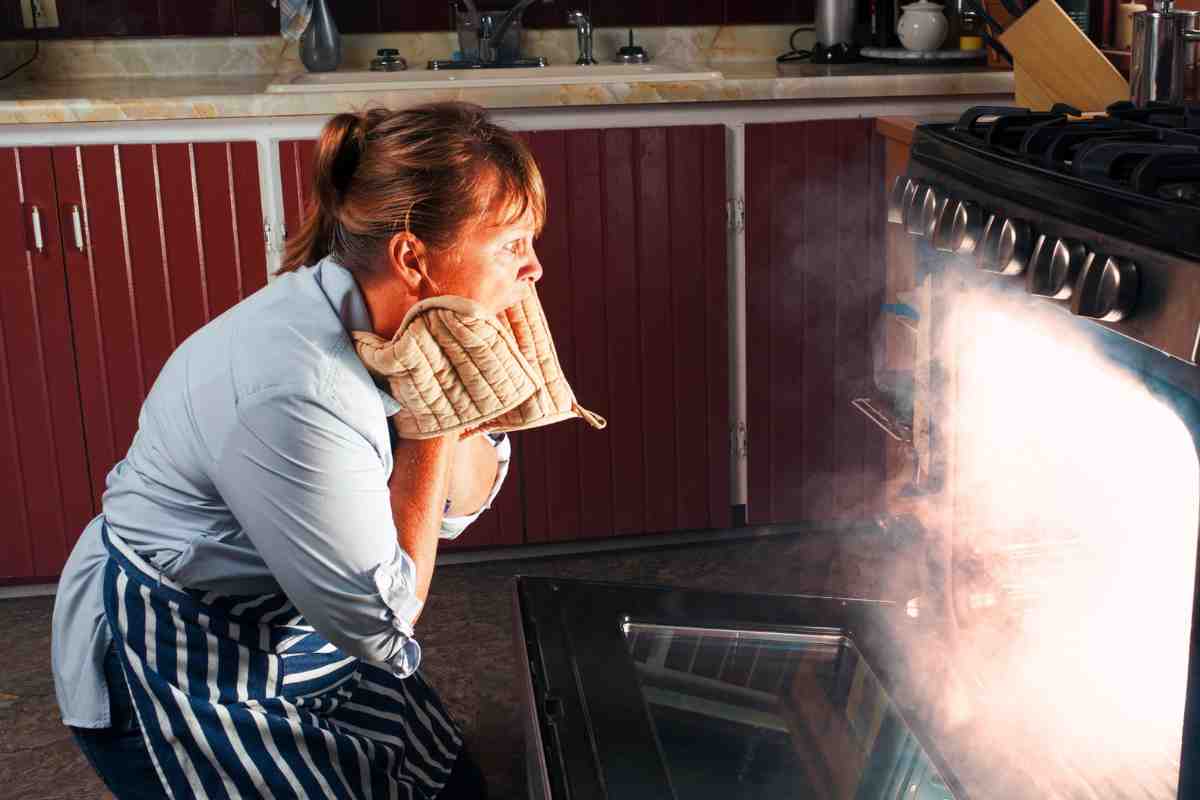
[897,103,1200,799]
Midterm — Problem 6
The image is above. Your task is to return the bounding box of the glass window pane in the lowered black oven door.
[624,624,952,800]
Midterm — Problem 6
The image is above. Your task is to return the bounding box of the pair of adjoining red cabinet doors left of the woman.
[0,142,266,582]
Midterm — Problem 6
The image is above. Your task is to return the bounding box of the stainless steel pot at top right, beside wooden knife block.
[1129,0,1200,107]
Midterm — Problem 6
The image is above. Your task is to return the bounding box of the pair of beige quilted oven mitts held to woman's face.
[352,289,605,439]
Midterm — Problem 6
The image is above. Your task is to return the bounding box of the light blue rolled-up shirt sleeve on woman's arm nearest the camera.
[216,390,421,676]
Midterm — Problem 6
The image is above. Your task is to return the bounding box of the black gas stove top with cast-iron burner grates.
[913,103,1200,259]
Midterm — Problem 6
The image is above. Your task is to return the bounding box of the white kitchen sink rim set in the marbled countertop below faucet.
[266,64,721,92]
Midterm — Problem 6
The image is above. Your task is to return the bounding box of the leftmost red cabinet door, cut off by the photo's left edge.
[0,148,95,583]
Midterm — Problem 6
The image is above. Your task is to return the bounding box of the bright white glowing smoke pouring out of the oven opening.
[897,283,1200,800]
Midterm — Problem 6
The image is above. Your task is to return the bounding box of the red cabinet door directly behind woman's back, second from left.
[54,142,266,506]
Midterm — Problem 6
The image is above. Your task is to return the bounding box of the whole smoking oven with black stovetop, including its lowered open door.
[514,104,1200,800]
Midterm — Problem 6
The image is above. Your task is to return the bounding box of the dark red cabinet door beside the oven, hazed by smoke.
[746,119,884,524]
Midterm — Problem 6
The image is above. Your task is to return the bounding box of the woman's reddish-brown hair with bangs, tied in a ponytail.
[280,102,546,272]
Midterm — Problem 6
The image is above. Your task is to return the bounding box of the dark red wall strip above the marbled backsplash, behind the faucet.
[0,0,814,38]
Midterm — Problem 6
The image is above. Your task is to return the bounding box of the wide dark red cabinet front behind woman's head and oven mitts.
[280,126,730,549]
